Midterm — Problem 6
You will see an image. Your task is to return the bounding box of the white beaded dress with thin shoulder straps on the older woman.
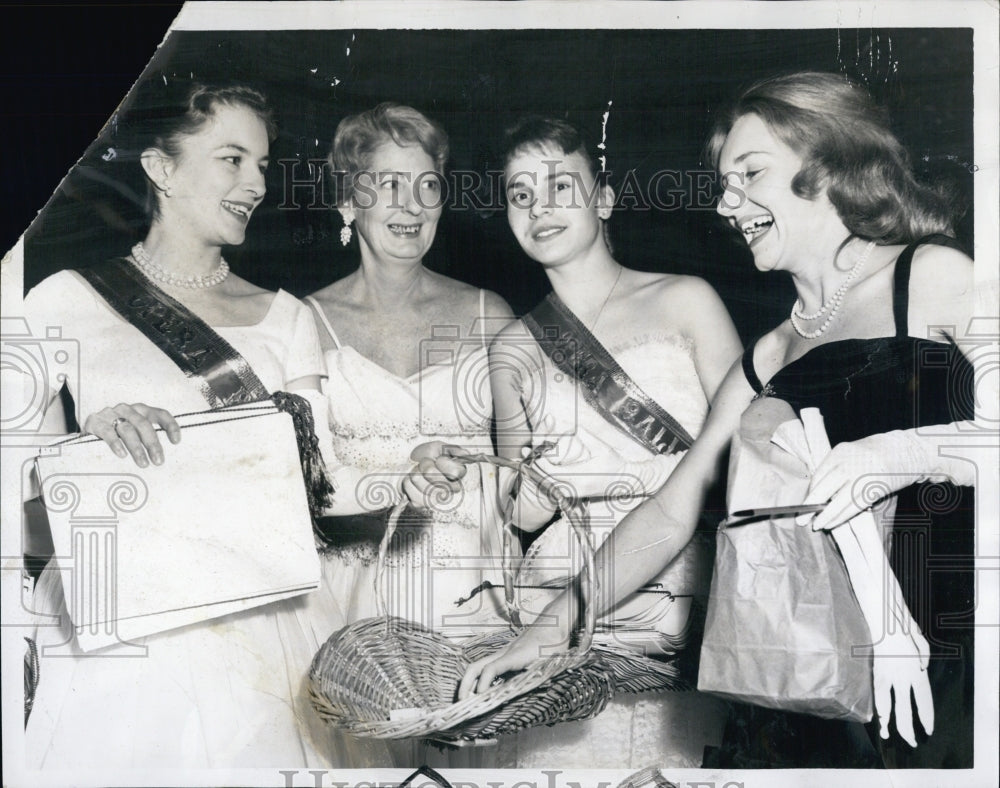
[309,291,502,638]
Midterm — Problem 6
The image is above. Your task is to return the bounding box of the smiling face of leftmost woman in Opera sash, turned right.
[158,104,268,246]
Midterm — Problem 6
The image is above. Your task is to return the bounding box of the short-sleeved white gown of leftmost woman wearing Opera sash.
[24,271,386,774]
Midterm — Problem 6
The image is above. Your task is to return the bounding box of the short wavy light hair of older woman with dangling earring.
[329,102,448,203]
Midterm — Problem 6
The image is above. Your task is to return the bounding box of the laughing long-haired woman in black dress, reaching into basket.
[461,73,975,768]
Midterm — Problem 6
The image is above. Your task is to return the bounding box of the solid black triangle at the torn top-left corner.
[0,2,182,262]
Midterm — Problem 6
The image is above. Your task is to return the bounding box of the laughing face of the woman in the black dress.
[717,114,848,271]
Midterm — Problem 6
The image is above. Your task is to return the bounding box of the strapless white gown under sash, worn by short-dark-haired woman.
[497,326,725,769]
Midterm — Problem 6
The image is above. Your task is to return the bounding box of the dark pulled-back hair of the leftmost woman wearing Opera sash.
[121,77,278,219]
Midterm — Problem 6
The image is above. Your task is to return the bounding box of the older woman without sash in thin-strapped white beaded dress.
[307,104,512,637]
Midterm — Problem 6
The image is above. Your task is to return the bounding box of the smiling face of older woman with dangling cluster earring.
[343,142,442,262]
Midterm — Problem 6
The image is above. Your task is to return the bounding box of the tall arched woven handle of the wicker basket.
[374,450,598,655]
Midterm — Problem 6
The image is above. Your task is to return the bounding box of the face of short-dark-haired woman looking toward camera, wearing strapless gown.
[504,146,614,266]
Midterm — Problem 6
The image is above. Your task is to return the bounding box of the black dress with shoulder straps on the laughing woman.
[705,236,975,768]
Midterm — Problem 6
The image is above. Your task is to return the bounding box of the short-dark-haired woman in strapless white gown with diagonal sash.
[463,118,740,768]
